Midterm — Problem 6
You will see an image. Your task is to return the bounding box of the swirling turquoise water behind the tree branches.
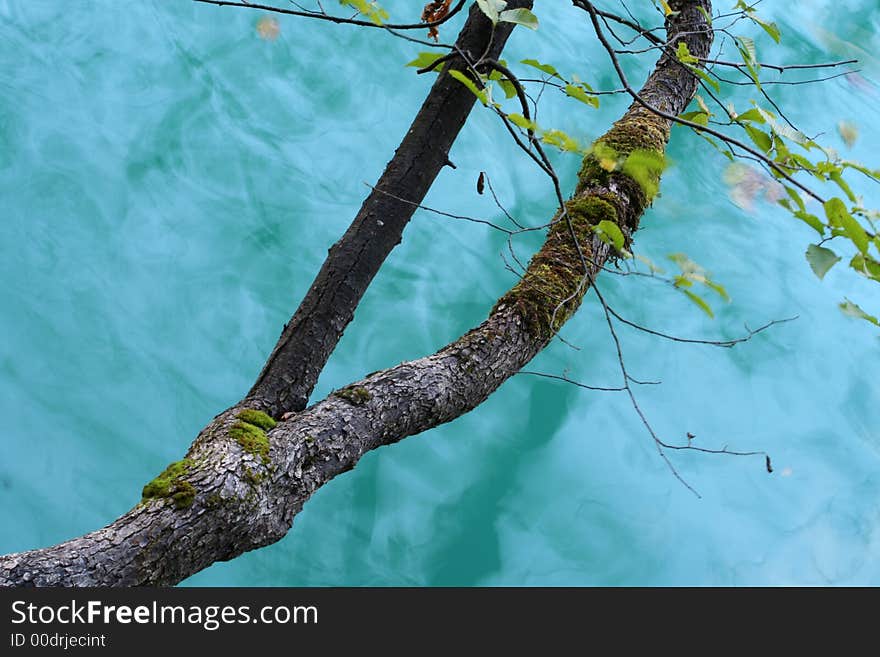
[0,0,880,586]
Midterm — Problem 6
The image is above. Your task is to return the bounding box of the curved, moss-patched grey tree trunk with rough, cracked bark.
[0,0,712,586]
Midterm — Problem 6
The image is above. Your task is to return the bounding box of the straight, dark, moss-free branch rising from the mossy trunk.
[247,0,532,416]
